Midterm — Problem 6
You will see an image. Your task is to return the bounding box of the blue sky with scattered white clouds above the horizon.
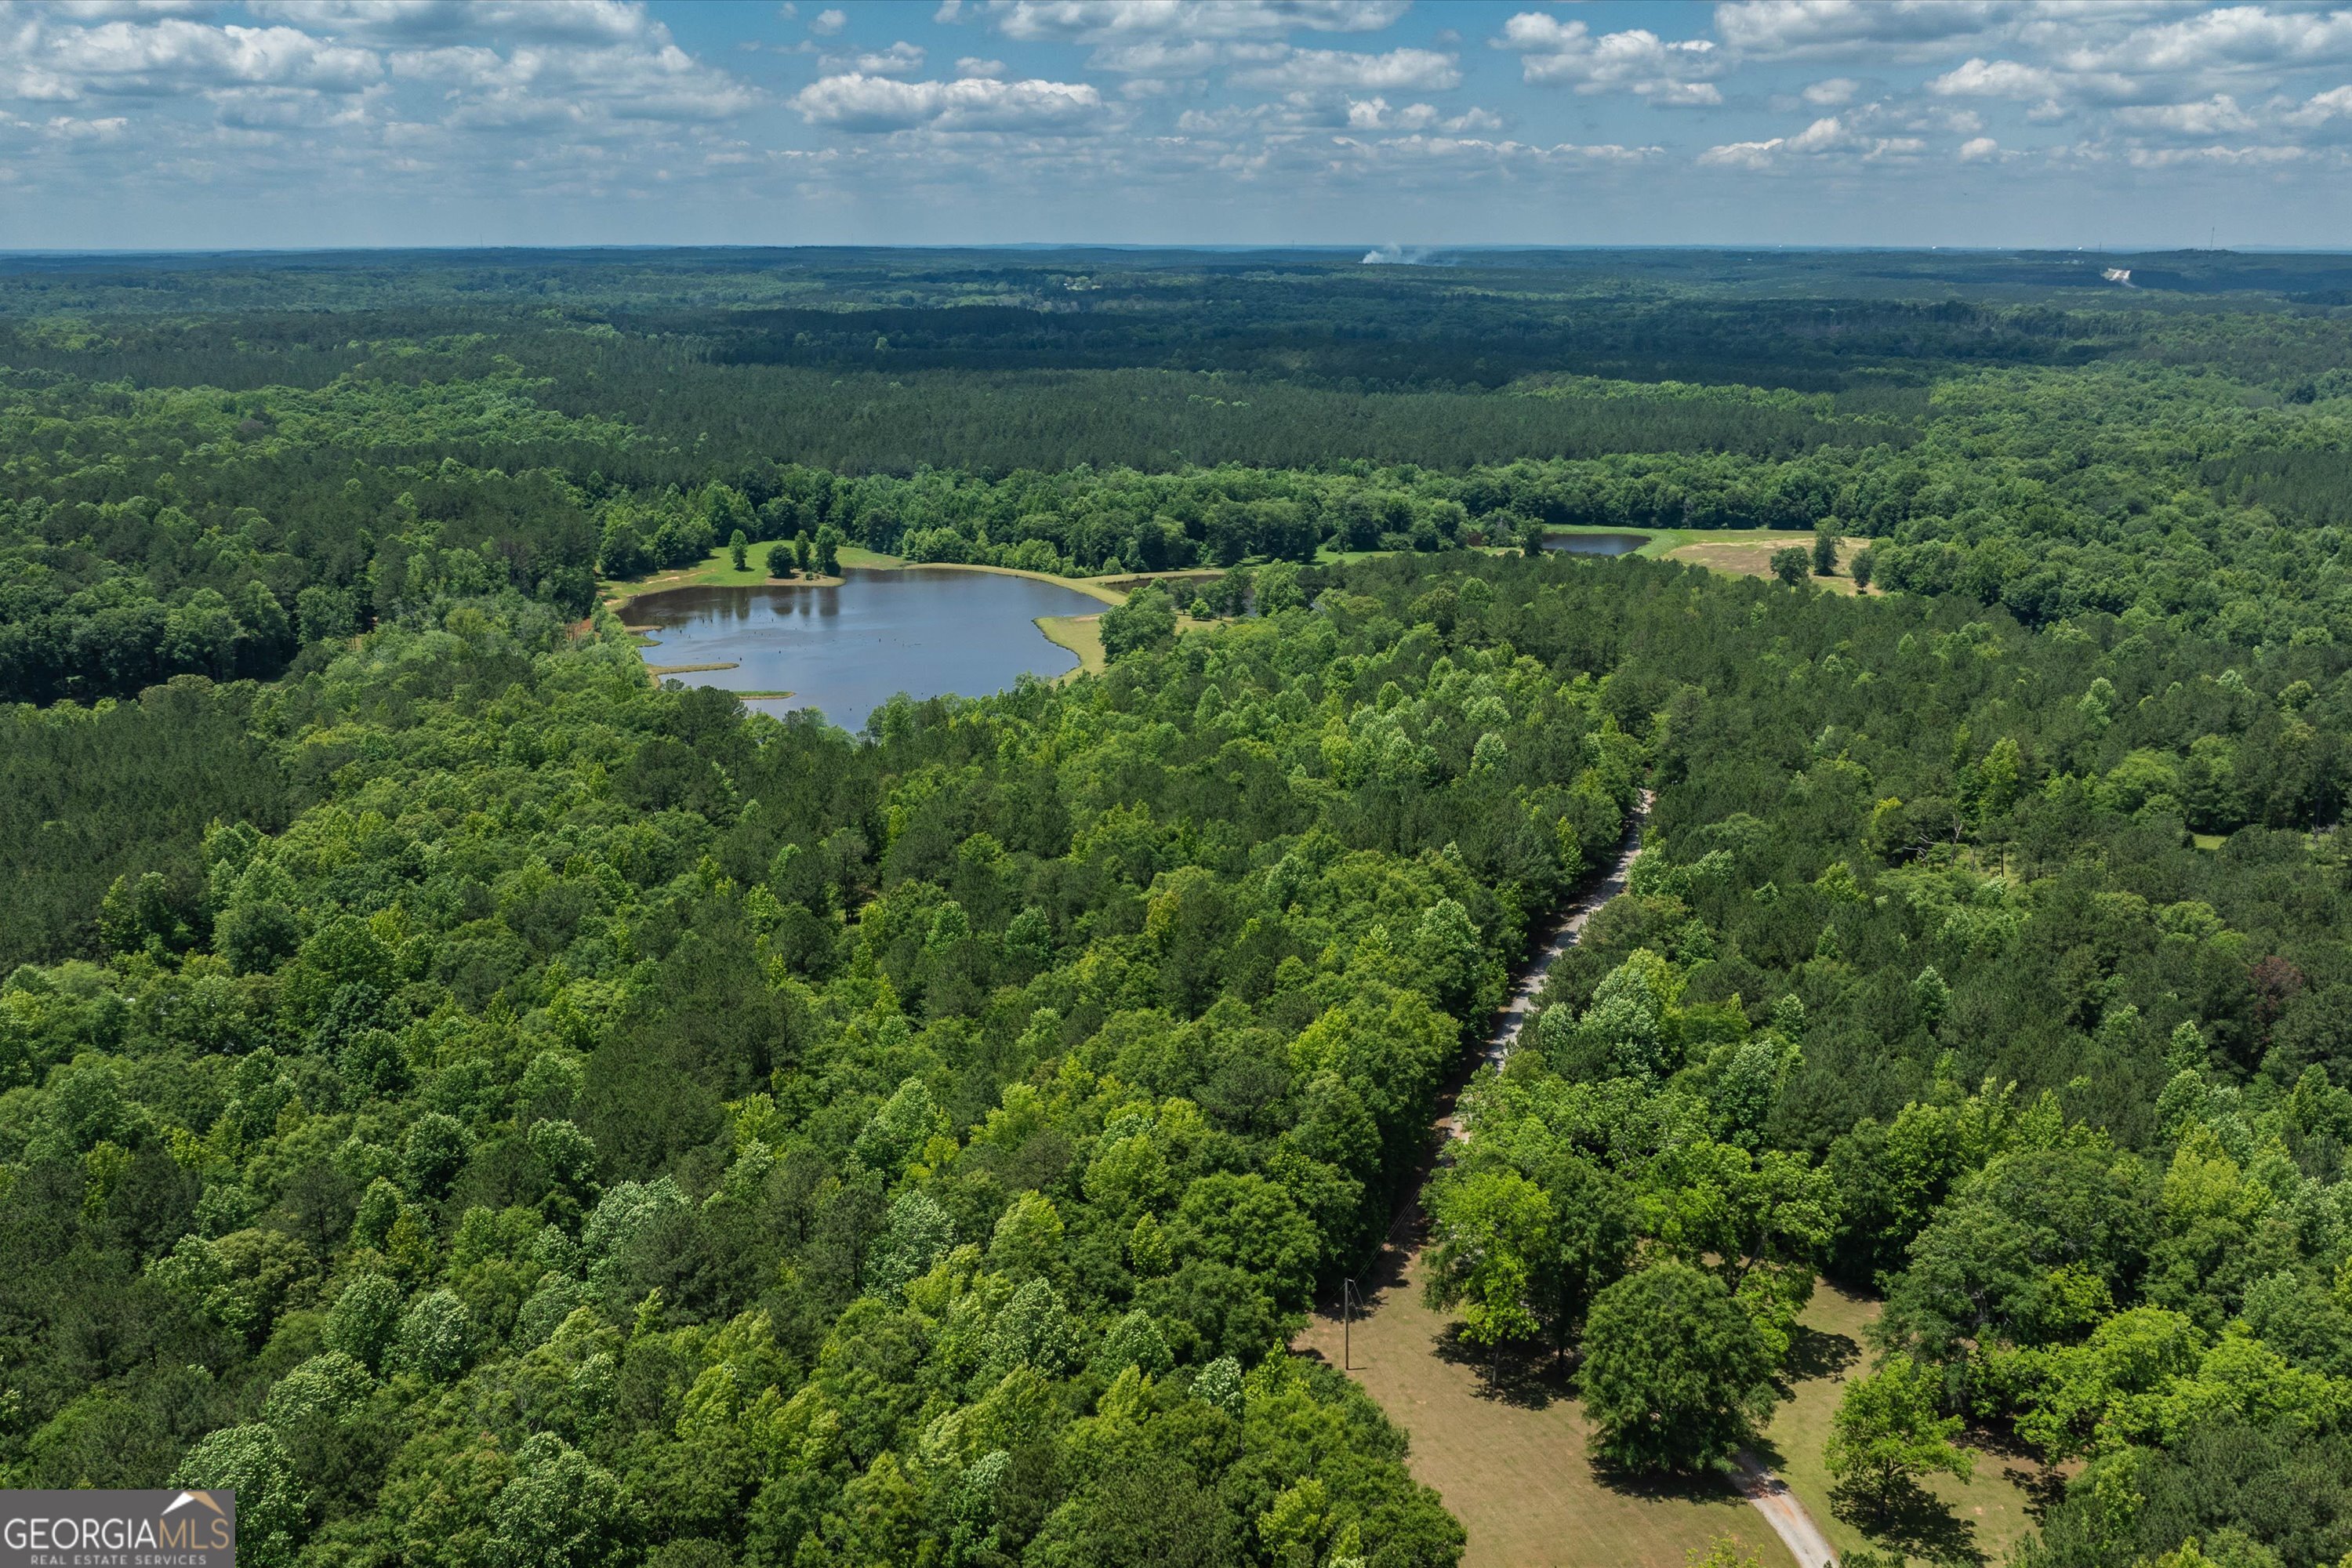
[0,0,2352,249]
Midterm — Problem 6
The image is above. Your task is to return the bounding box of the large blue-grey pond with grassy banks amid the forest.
[621,567,1108,731]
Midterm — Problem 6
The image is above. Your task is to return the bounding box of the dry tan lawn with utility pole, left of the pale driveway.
[1294,1248,1795,1568]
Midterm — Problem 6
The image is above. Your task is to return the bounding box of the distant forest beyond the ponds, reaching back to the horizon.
[0,254,2352,719]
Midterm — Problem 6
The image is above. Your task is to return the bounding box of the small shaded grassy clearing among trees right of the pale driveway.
[1764,1283,2042,1563]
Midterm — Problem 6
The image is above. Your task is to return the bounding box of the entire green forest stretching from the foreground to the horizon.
[0,252,2352,1568]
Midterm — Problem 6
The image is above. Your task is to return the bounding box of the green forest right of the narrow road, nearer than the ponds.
[1397,550,2352,1568]
